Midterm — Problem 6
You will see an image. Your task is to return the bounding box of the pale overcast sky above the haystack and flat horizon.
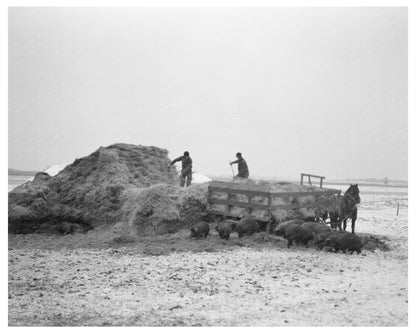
[8,7,408,179]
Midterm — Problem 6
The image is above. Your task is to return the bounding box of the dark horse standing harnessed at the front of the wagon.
[330,184,361,233]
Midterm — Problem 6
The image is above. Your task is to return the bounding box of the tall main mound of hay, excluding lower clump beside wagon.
[9,144,177,233]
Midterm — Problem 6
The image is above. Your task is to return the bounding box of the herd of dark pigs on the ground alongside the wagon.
[190,217,365,254]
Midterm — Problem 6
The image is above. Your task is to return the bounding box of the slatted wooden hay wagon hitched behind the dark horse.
[208,174,341,231]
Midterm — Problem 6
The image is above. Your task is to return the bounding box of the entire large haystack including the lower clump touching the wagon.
[9,144,206,233]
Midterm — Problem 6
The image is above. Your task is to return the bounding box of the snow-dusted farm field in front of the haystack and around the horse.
[9,182,408,326]
